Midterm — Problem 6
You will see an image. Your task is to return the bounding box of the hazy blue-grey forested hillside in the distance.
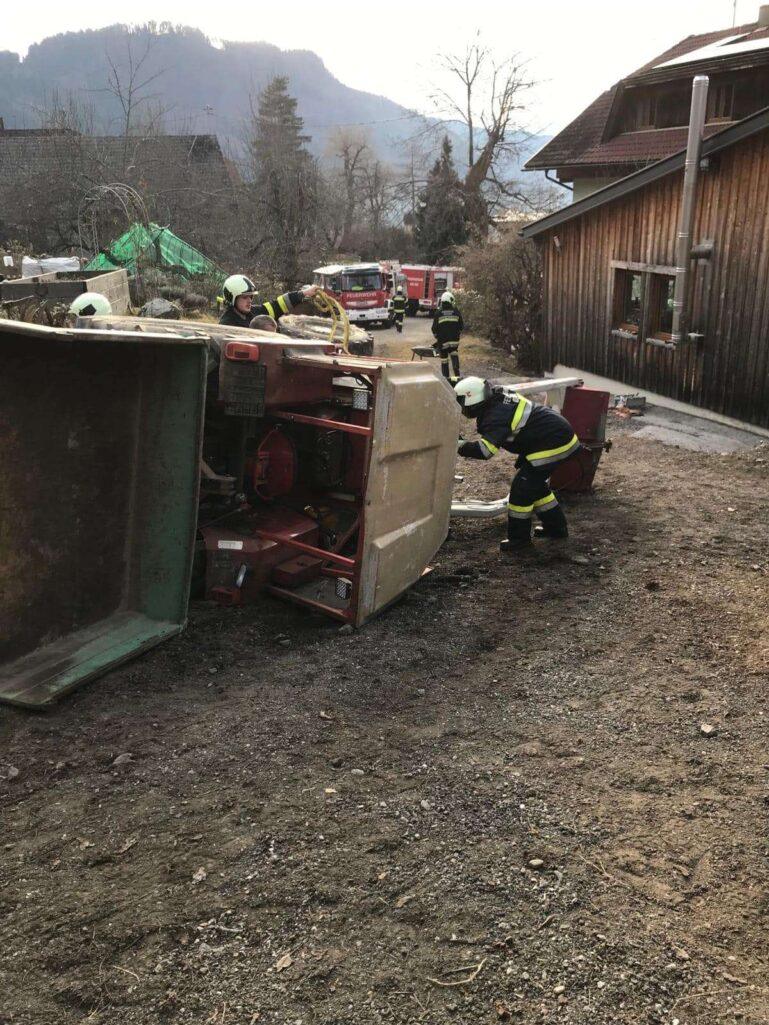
[0,25,547,180]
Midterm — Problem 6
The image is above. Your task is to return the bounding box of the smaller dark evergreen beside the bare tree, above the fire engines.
[415,135,468,263]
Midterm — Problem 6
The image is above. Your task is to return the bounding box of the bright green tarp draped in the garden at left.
[85,221,221,277]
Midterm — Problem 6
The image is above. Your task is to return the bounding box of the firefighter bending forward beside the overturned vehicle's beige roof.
[454,377,579,552]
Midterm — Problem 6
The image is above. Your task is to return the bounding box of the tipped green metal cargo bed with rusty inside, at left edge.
[0,321,206,707]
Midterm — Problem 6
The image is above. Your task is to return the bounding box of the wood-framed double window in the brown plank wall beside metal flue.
[611,261,676,341]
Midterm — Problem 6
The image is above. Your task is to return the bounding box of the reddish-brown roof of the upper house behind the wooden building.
[524,23,767,170]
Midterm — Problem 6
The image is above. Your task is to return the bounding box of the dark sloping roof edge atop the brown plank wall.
[520,107,769,239]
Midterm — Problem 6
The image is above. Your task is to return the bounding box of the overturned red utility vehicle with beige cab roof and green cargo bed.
[0,318,457,706]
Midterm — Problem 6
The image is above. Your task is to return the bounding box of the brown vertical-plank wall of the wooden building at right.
[537,128,769,427]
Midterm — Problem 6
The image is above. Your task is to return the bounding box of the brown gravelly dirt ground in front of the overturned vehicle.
[0,330,769,1025]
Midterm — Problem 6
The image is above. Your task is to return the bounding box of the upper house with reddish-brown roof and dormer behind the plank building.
[524,5,769,201]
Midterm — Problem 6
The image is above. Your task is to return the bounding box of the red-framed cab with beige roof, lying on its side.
[196,328,457,625]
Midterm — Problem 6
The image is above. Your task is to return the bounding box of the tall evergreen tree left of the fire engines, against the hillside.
[248,76,318,287]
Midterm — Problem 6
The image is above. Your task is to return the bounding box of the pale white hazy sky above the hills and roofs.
[0,0,760,133]
